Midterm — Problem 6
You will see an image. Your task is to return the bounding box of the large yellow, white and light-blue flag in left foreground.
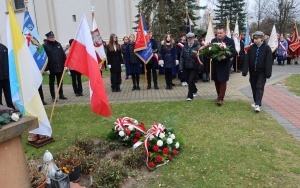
[7,1,52,136]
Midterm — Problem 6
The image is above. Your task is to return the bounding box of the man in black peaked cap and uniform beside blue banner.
[43,31,67,102]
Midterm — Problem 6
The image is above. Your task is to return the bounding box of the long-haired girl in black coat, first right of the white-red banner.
[106,34,123,92]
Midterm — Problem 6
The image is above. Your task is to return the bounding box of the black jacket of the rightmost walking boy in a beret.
[242,42,273,78]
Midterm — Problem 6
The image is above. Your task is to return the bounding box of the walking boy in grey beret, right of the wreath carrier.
[242,31,273,112]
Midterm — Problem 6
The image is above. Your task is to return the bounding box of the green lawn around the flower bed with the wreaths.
[23,99,300,188]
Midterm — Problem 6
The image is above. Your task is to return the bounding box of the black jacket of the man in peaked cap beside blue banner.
[43,40,66,73]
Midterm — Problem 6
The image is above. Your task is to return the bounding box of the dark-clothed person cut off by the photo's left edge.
[0,43,15,109]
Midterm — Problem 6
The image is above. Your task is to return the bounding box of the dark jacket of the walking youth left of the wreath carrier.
[179,41,200,71]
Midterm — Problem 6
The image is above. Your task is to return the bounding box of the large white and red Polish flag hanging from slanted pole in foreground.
[65,15,111,117]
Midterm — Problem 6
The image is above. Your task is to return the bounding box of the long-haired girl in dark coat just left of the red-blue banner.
[126,34,141,90]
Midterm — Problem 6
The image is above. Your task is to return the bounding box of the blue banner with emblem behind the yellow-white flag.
[23,11,47,71]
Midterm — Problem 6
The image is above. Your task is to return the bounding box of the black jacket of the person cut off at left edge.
[0,44,9,80]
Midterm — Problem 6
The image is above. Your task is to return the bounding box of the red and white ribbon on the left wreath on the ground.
[115,117,146,134]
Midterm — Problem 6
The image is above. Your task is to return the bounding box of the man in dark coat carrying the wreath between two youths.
[211,28,236,106]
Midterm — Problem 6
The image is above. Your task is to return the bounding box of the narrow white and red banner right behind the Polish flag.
[91,12,106,67]
